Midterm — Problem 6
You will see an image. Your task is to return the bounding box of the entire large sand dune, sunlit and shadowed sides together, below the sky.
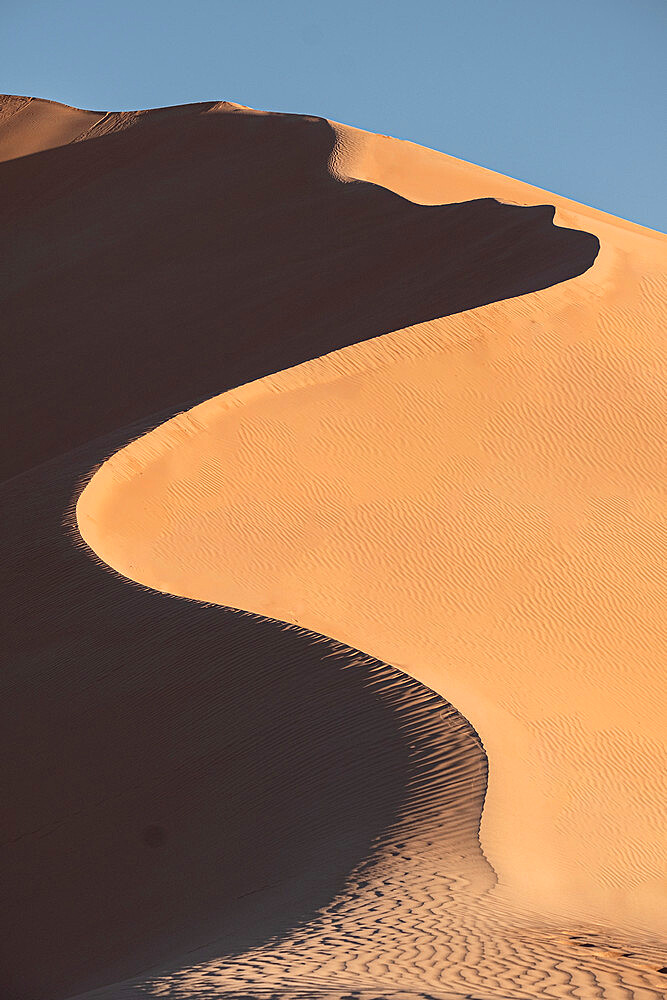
[0,98,667,1000]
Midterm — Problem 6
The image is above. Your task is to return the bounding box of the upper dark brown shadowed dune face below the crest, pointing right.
[0,112,598,476]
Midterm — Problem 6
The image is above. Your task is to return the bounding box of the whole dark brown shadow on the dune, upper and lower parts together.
[0,105,597,1000]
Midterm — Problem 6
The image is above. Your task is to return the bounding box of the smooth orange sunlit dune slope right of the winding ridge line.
[78,107,666,927]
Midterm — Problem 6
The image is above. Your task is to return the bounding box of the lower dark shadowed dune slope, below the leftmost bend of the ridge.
[0,424,492,1000]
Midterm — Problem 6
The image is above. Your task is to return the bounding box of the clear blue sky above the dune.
[5,0,667,231]
